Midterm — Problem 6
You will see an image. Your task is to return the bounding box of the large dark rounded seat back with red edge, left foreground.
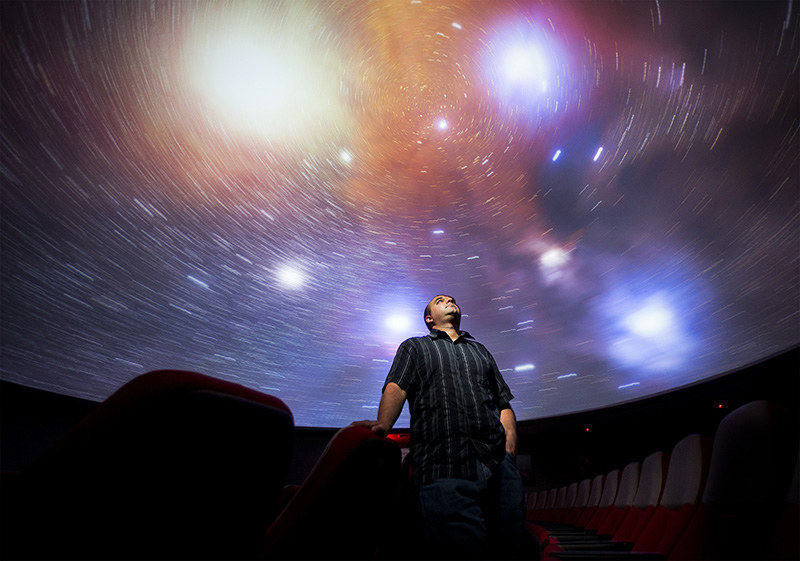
[3,370,294,559]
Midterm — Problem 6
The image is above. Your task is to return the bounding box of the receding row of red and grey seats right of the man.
[527,401,800,560]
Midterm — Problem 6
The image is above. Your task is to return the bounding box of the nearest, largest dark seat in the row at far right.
[669,401,797,559]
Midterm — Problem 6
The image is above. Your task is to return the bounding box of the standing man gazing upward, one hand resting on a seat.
[355,294,525,559]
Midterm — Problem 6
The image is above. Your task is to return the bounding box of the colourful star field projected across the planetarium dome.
[0,0,800,427]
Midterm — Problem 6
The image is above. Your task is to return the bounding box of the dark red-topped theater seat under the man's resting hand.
[262,426,404,559]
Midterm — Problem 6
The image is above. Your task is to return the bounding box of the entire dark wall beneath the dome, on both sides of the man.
[0,348,800,489]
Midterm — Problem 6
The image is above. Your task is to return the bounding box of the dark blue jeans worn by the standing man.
[419,453,525,559]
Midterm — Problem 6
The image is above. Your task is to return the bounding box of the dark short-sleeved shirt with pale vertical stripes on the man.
[383,329,514,485]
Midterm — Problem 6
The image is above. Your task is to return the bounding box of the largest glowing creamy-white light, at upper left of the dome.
[191,3,344,140]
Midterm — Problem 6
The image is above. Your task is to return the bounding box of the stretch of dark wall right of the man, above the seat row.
[519,348,800,490]
